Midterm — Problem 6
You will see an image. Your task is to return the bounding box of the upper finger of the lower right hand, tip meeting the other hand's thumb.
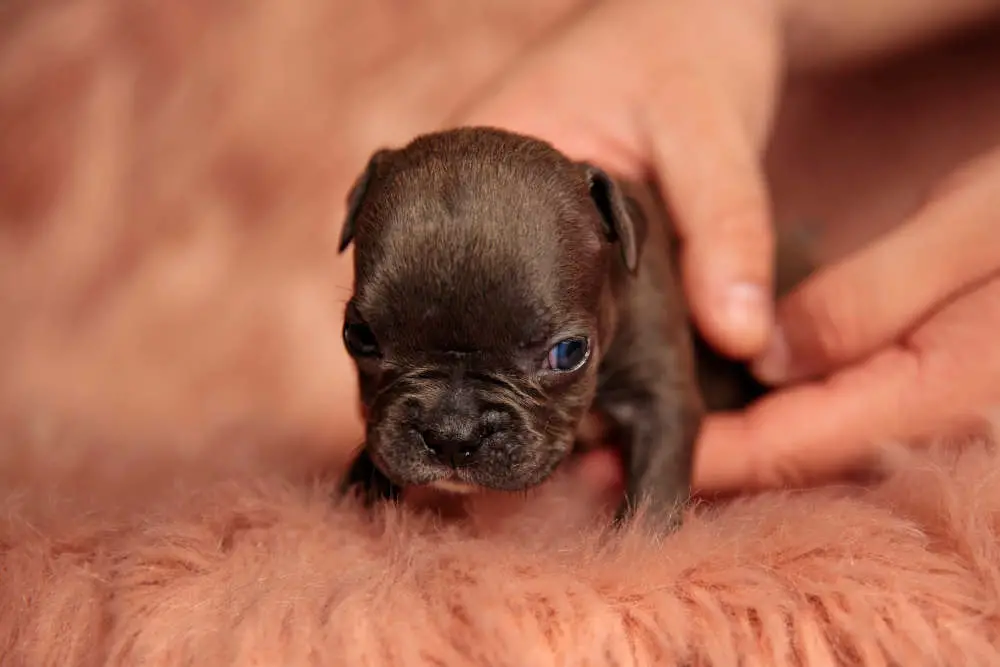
[754,151,1000,383]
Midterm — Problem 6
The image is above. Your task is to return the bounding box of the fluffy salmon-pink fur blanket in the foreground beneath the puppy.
[0,436,1000,667]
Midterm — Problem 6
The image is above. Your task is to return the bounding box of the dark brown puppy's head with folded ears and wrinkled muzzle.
[341,128,643,490]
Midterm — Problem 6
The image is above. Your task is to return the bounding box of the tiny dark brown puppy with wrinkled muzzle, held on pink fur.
[340,127,800,530]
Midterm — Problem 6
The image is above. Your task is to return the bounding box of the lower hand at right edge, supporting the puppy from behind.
[695,149,1000,491]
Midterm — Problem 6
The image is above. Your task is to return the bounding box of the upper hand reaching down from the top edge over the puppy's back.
[454,0,779,358]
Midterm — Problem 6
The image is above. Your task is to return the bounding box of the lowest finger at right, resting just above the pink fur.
[695,277,1000,492]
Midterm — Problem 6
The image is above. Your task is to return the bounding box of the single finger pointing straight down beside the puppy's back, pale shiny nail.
[644,76,774,358]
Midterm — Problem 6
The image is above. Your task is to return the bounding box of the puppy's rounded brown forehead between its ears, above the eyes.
[355,131,601,356]
